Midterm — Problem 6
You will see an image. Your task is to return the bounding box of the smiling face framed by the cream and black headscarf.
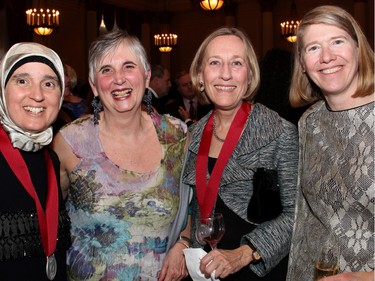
[5,62,61,133]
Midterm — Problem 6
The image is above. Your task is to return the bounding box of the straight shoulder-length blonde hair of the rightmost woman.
[289,5,374,107]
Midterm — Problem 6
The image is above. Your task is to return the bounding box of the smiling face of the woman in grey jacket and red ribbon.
[198,35,250,109]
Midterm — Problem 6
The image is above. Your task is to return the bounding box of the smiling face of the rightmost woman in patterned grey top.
[301,24,358,97]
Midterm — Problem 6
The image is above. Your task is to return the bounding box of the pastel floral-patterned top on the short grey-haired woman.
[61,114,186,280]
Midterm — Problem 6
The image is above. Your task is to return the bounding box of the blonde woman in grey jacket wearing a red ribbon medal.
[182,25,298,281]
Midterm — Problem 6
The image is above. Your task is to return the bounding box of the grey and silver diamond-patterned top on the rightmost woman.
[288,99,375,281]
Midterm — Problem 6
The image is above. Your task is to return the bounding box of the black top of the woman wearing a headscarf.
[0,148,70,281]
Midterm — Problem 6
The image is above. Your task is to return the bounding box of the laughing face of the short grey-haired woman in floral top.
[90,43,150,113]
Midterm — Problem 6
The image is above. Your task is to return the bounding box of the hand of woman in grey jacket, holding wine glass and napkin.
[200,246,251,278]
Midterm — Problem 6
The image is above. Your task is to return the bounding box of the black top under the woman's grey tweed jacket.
[204,157,288,281]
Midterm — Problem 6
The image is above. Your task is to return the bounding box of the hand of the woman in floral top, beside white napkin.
[158,243,188,281]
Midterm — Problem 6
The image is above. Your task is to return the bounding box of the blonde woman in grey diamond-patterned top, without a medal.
[288,6,374,281]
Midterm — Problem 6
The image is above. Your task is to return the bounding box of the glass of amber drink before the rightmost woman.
[315,235,340,281]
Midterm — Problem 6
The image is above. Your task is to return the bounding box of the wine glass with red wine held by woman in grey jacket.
[196,213,225,250]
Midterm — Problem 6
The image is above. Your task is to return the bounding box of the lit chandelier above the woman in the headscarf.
[26,0,60,36]
